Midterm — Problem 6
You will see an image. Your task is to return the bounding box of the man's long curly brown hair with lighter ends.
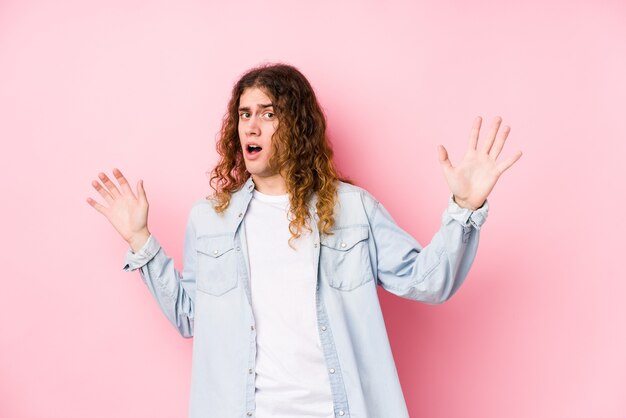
[210,64,349,238]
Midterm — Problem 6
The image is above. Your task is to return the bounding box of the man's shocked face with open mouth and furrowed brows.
[239,87,278,179]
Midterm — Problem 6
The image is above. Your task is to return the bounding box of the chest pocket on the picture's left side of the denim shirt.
[196,235,237,296]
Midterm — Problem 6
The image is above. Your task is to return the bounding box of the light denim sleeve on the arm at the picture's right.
[370,196,489,303]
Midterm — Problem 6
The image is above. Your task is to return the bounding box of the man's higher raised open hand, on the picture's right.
[439,116,522,210]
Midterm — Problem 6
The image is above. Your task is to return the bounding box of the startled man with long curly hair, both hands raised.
[88,65,521,418]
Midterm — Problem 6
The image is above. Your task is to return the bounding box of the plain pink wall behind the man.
[0,0,626,418]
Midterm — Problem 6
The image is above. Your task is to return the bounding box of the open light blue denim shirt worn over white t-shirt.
[124,178,488,418]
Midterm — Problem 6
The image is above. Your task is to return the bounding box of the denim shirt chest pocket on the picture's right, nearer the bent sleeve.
[320,226,374,290]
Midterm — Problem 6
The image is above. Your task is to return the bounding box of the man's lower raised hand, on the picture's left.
[87,168,150,252]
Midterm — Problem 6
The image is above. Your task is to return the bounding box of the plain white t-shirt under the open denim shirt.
[244,190,334,418]
